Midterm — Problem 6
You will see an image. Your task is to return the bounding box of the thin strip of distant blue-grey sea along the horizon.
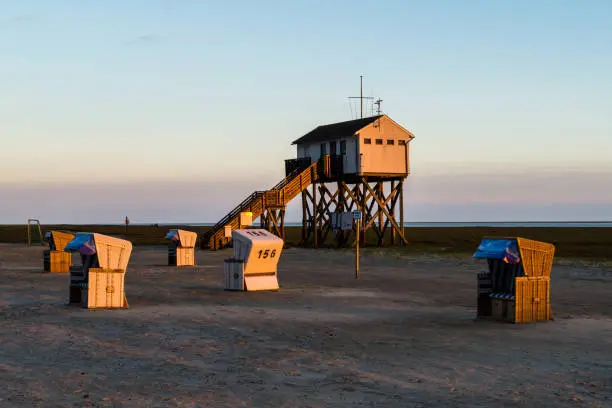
[130,221,612,228]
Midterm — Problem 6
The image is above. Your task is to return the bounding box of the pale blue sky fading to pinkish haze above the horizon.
[0,0,612,224]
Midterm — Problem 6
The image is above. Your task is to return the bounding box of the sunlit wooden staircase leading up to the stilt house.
[200,156,329,250]
